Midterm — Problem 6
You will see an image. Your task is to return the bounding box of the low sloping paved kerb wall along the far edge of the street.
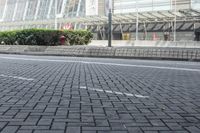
[0,45,200,61]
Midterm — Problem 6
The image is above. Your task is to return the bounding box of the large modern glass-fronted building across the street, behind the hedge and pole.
[0,0,200,41]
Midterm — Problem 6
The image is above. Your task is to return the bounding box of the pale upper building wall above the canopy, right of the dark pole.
[114,0,200,14]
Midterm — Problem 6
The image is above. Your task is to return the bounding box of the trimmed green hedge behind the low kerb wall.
[0,29,93,46]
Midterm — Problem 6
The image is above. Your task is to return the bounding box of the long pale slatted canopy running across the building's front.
[0,9,200,29]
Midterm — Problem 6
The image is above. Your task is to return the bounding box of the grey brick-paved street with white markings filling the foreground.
[0,55,200,133]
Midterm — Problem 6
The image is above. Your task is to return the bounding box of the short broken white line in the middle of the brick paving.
[80,86,149,99]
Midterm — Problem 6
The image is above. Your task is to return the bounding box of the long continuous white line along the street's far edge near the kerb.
[0,57,200,72]
